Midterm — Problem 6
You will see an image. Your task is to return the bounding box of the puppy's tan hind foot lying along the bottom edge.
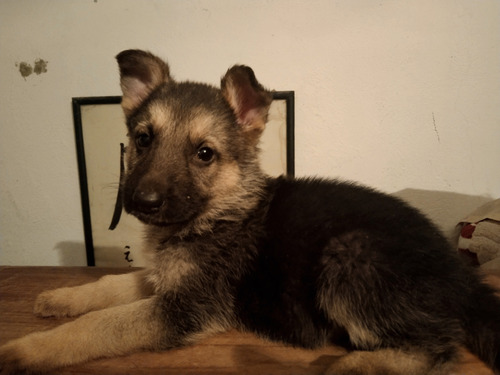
[326,349,451,375]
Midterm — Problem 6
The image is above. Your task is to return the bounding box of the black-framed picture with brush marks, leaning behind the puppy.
[72,91,295,267]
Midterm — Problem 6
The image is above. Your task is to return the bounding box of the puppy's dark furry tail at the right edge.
[465,284,500,374]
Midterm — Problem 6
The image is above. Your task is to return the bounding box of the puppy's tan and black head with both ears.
[117,50,272,226]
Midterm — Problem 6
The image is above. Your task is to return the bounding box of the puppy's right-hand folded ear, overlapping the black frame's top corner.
[221,65,272,137]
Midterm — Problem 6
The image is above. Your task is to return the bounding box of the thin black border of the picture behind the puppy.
[72,91,295,266]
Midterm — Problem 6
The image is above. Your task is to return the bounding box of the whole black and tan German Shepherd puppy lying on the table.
[0,50,500,375]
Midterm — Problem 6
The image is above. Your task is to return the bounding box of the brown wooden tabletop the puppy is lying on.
[0,266,500,375]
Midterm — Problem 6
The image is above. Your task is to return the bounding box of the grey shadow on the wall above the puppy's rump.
[392,189,493,243]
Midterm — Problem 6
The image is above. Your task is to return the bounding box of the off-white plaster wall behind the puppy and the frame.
[0,0,500,265]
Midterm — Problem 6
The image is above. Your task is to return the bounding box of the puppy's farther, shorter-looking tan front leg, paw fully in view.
[34,270,152,317]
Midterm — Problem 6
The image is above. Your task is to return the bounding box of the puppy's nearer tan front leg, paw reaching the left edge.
[0,297,169,374]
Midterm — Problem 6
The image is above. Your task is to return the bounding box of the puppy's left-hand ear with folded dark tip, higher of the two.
[116,50,171,116]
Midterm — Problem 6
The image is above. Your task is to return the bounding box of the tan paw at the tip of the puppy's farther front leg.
[34,288,85,318]
